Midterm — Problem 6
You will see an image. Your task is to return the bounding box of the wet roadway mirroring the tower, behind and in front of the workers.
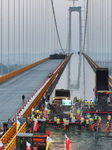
[47,54,112,150]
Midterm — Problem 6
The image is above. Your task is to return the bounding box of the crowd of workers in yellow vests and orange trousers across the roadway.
[27,97,111,135]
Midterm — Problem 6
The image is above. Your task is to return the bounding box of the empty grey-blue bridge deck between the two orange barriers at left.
[0,59,62,122]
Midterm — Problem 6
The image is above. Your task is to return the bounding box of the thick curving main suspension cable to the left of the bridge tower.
[51,0,65,53]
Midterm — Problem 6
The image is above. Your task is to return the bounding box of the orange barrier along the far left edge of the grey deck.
[0,57,50,83]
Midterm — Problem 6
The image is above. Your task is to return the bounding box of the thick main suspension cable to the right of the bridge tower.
[83,0,88,52]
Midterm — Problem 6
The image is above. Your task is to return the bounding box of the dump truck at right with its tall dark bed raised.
[95,68,112,111]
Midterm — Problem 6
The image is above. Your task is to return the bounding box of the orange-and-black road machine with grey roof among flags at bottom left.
[16,119,50,150]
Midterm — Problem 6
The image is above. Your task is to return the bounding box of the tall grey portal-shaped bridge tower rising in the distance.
[68,7,82,53]
